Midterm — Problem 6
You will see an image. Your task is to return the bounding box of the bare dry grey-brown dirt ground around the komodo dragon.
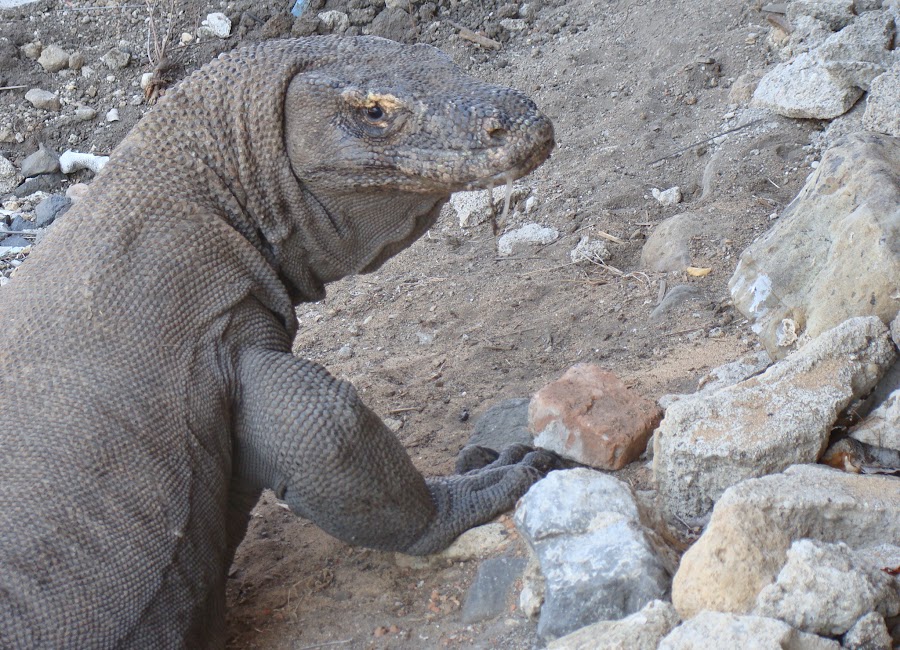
[0,0,822,649]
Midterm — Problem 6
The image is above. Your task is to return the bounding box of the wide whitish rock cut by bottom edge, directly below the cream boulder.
[659,612,841,650]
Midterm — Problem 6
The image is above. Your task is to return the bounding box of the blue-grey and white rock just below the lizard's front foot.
[514,469,669,639]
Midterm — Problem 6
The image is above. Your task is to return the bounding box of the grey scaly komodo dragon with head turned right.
[0,37,557,649]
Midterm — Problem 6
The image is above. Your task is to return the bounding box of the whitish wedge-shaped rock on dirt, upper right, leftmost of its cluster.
[750,52,863,120]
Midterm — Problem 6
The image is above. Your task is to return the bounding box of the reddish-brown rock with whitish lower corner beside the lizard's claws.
[528,364,662,470]
